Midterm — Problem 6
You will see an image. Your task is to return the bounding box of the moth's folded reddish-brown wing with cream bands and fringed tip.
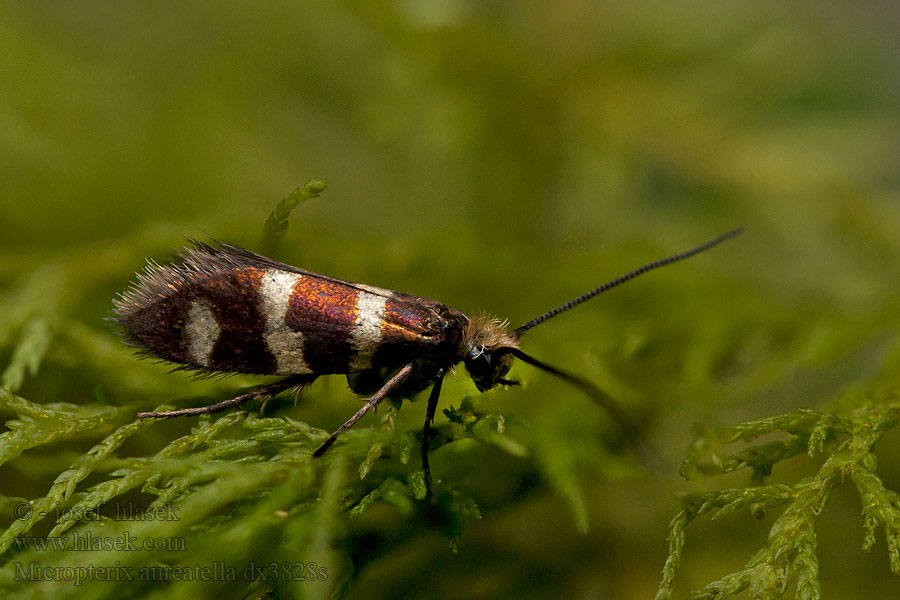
[112,241,465,374]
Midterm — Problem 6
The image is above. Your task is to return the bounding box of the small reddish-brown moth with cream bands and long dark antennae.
[112,228,743,494]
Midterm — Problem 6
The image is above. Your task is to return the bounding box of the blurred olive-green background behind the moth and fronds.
[0,0,900,600]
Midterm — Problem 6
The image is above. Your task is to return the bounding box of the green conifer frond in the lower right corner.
[656,402,900,600]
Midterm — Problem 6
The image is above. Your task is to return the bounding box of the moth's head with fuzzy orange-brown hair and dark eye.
[460,315,519,392]
